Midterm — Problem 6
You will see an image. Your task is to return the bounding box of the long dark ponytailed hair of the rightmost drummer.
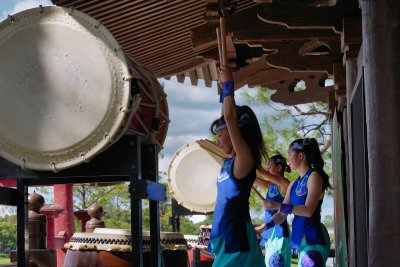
[289,138,332,191]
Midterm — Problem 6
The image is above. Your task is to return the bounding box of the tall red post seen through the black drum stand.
[54,184,75,267]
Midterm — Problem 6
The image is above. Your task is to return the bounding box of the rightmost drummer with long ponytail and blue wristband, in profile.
[266,138,332,267]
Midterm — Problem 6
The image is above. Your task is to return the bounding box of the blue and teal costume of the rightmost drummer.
[290,169,330,267]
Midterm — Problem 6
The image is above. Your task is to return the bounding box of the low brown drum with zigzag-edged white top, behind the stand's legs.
[64,228,189,267]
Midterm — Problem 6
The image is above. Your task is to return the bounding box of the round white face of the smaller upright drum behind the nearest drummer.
[168,140,227,213]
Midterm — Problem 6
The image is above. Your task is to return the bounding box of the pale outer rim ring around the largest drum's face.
[0,6,140,172]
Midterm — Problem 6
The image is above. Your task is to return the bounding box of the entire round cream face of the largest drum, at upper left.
[0,7,134,171]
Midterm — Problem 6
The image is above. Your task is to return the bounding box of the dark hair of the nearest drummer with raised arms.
[210,105,266,167]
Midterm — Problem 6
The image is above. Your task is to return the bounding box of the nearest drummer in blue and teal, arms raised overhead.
[210,68,265,267]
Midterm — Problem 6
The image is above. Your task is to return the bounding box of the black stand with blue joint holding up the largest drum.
[0,135,166,267]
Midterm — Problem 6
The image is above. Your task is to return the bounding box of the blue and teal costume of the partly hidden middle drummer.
[260,184,292,267]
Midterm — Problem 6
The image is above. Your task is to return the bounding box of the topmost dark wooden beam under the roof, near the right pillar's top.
[258,0,361,33]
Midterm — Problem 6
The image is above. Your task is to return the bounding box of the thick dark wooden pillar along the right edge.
[361,0,400,266]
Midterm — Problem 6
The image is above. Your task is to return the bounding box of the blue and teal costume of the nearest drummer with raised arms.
[210,157,265,267]
